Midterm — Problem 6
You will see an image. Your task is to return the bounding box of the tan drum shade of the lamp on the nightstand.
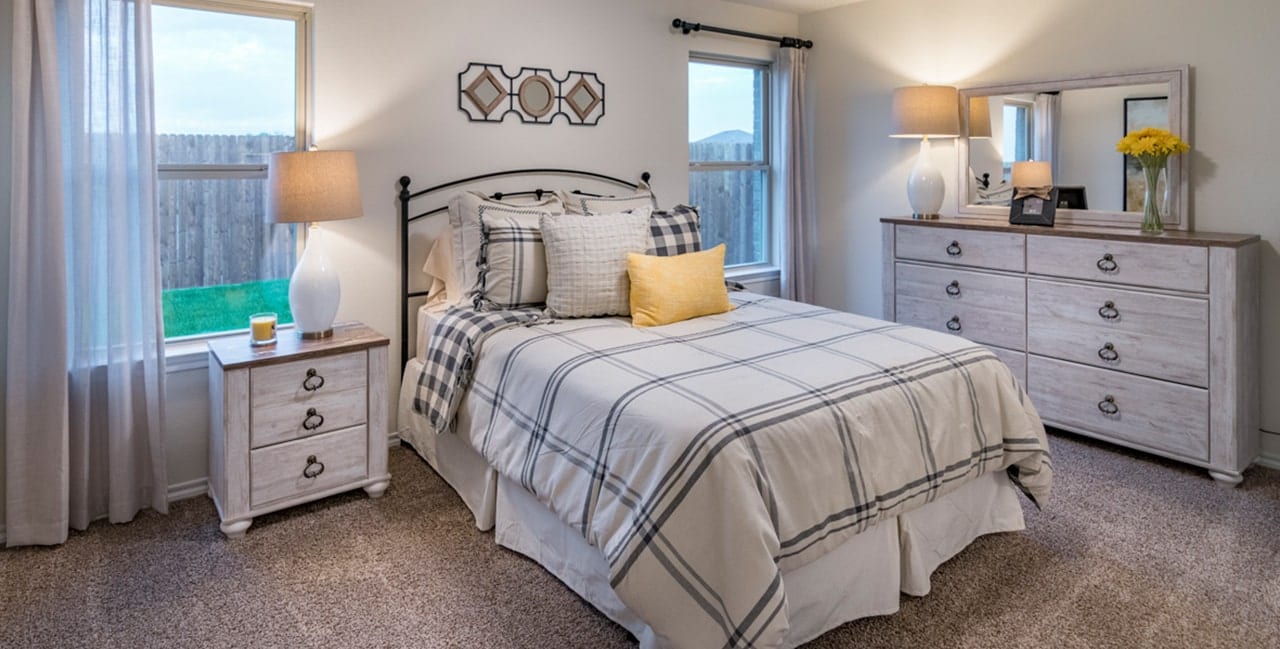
[266,151,365,223]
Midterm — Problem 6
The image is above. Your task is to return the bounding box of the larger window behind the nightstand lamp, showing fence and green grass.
[151,0,310,339]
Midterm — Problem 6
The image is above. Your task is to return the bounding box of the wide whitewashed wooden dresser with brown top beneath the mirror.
[881,219,1260,484]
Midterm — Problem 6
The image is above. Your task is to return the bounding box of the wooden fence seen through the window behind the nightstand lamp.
[156,134,297,289]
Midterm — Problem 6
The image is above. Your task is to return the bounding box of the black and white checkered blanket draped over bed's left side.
[413,306,543,433]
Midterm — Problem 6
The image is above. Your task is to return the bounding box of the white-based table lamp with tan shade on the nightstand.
[266,151,364,338]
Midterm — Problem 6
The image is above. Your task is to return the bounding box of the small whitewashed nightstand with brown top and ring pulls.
[209,323,390,539]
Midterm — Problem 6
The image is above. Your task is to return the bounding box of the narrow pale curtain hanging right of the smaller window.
[773,47,818,302]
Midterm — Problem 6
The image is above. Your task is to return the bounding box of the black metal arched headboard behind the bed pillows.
[399,169,650,369]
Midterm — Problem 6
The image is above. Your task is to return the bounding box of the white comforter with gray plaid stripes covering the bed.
[414,293,1052,648]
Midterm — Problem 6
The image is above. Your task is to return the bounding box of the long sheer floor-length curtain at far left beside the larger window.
[4,0,166,545]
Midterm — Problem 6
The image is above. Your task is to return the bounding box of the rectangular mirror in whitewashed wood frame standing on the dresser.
[957,68,1188,228]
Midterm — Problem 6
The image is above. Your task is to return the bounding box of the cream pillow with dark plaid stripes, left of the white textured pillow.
[471,214,547,311]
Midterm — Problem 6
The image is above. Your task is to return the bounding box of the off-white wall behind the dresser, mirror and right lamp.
[800,0,1280,457]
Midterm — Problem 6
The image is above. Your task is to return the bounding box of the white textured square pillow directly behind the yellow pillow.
[541,207,653,317]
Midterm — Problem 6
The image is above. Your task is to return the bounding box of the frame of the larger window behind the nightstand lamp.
[152,0,314,345]
